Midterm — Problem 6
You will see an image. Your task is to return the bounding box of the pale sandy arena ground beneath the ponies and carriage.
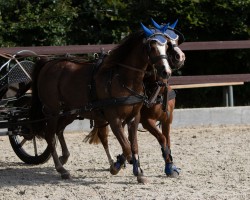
[0,125,250,200]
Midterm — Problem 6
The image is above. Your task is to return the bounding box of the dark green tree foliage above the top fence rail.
[0,0,250,46]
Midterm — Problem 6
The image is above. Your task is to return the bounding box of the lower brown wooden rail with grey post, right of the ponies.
[169,74,250,106]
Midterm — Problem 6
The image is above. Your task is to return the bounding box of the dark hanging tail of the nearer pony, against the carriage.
[30,58,48,137]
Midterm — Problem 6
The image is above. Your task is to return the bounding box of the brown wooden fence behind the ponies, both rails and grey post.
[0,40,250,106]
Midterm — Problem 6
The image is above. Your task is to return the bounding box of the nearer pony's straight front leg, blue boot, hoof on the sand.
[128,114,148,183]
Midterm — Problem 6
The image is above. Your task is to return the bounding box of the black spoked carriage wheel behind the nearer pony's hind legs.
[9,135,51,165]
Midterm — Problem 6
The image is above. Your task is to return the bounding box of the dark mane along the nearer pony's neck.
[104,31,144,68]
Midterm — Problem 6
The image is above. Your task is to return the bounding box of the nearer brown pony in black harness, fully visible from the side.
[30,28,171,182]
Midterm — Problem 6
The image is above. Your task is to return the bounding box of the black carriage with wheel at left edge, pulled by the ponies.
[0,50,51,164]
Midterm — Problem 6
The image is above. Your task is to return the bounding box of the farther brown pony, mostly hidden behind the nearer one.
[84,24,185,177]
